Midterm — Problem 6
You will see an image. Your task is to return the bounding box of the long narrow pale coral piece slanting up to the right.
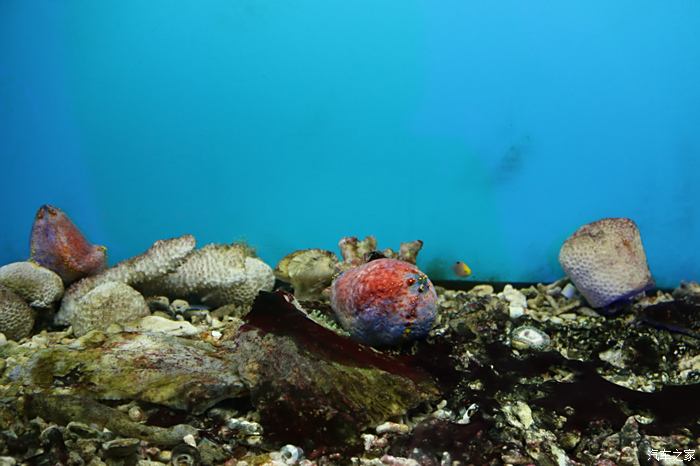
[55,235,195,325]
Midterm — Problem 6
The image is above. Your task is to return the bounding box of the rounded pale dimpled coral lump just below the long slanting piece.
[70,282,150,336]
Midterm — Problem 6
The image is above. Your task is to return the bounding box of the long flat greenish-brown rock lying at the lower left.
[8,331,246,412]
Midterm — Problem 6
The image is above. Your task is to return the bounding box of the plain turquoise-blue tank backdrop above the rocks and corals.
[0,0,700,286]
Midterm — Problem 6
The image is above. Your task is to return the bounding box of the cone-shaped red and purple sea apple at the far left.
[30,205,107,284]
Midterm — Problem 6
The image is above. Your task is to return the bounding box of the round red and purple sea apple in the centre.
[331,259,437,345]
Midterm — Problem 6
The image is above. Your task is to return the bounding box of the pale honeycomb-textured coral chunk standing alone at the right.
[559,218,654,308]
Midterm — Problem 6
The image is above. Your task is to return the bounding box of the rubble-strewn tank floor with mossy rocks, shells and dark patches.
[0,280,700,466]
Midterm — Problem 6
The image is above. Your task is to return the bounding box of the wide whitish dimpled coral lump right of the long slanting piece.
[142,243,275,307]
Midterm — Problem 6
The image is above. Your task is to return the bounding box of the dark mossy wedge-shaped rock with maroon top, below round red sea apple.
[241,293,438,451]
